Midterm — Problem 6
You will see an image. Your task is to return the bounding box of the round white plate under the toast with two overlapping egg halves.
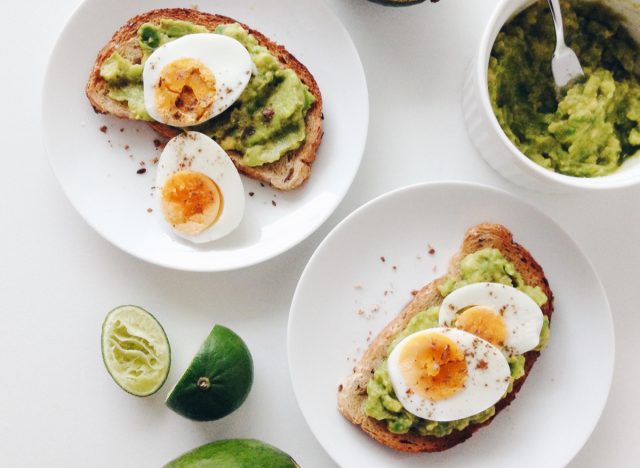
[288,182,614,468]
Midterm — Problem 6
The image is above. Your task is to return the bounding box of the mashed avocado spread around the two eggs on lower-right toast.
[365,248,549,437]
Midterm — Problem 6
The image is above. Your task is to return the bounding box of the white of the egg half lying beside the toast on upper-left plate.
[156,132,245,244]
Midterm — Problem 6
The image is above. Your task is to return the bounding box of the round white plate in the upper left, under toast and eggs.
[43,0,369,271]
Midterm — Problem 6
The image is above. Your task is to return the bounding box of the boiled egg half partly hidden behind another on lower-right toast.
[438,283,544,354]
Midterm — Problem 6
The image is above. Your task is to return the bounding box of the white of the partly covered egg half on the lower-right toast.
[438,283,543,354]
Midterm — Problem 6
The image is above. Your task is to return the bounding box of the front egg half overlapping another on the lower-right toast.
[387,328,511,421]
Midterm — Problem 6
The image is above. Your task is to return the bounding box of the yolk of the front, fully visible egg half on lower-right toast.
[399,333,467,400]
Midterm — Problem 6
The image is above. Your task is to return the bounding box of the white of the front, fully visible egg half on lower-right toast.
[387,327,511,421]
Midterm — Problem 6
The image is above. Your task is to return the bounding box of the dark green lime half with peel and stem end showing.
[166,325,253,421]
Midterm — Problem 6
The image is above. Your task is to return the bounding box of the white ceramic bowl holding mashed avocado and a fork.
[463,0,640,193]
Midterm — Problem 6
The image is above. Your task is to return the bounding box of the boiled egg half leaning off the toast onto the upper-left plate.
[156,132,245,244]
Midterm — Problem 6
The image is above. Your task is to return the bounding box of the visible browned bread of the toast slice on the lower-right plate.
[338,224,553,452]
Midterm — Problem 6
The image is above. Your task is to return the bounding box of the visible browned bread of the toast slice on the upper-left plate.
[86,8,323,190]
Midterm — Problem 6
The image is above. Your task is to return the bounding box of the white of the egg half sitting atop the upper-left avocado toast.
[142,33,254,123]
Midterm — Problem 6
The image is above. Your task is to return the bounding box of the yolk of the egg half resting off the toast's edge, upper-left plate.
[162,171,223,234]
